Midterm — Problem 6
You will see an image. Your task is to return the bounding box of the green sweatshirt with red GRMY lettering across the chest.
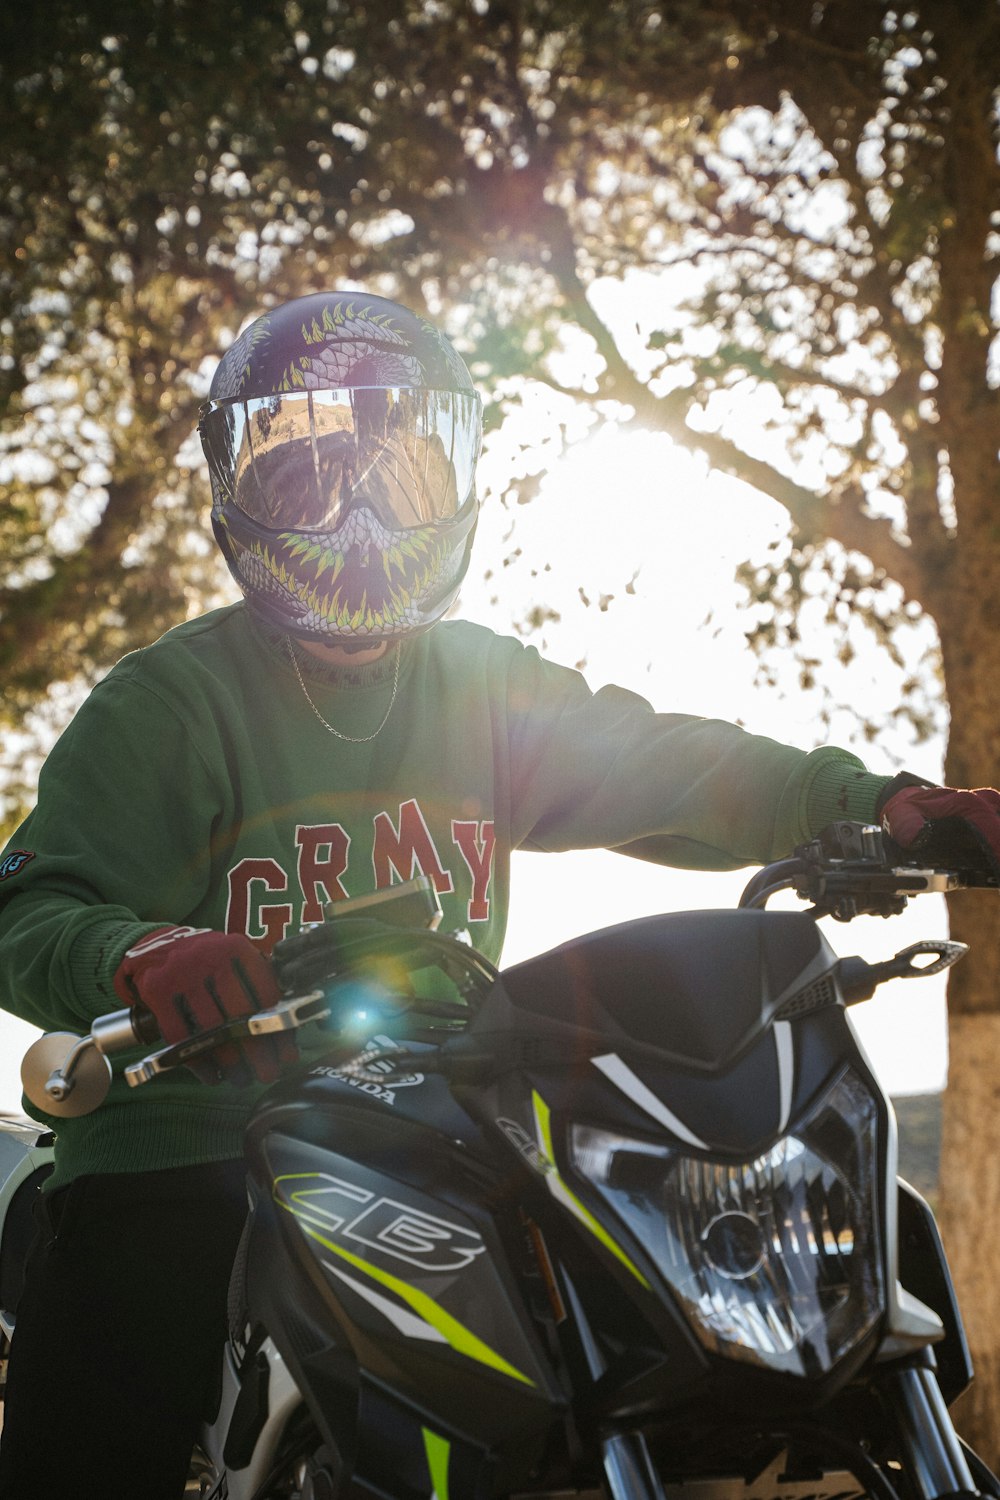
[0,605,888,1187]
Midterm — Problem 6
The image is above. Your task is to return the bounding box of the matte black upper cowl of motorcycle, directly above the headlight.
[479,911,837,1071]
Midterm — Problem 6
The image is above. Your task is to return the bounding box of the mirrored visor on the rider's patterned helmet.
[201,386,481,531]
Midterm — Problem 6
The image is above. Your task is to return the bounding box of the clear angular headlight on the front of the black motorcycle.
[570,1073,883,1377]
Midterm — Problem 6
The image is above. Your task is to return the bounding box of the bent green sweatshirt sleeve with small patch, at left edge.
[0,672,224,1031]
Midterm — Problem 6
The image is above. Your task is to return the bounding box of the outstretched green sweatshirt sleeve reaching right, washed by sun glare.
[508,648,888,870]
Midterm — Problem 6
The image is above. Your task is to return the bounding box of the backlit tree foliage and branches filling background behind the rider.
[0,0,1000,1458]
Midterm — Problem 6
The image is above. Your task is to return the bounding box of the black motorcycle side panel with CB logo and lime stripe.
[247,1070,565,1467]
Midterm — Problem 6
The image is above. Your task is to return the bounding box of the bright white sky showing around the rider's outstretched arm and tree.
[0,396,946,1110]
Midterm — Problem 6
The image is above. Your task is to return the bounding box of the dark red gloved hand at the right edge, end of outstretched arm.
[882,783,1000,876]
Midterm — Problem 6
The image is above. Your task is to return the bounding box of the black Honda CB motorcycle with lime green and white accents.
[0,822,1000,1500]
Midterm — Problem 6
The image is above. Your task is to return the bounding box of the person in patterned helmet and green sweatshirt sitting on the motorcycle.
[0,293,1000,1500]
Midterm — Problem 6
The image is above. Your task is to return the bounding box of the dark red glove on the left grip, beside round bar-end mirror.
[114,927,298,1083]
